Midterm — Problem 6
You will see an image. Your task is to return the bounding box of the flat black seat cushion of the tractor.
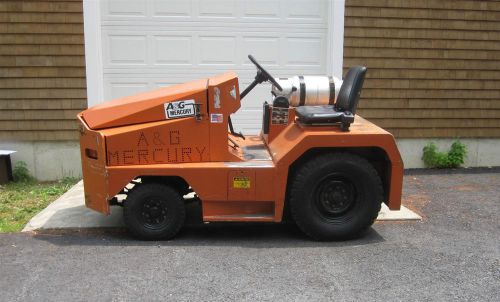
[295,105,354,124]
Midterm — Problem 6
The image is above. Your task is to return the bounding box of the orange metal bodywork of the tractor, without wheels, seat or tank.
[79,73,403,222]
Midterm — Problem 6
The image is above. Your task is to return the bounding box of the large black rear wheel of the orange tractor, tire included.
[290,153,383,240]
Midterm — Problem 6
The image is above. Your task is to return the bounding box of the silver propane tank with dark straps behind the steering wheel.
[272,76,342,107]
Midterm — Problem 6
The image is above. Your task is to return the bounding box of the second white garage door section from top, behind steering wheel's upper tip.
[102,30,327,74]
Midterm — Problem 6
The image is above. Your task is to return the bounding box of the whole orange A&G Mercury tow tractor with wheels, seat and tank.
[78,56,403,240]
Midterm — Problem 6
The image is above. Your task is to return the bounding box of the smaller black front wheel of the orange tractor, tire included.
[123,183,186,240]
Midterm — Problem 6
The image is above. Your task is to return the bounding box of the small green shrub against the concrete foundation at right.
[422,140,467,168]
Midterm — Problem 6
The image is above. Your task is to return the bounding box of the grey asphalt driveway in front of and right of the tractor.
[0,170,500,301]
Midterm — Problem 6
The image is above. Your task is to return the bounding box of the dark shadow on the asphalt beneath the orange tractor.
[33,223,385,249]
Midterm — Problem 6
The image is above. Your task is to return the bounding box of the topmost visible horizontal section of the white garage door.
[101,0,328,25]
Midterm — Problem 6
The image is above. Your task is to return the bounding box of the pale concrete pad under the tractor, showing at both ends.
[23,181,422,232]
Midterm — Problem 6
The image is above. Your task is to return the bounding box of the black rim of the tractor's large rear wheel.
[314,175,357,220]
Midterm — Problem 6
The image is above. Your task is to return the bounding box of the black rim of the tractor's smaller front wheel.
[139,198,168,230]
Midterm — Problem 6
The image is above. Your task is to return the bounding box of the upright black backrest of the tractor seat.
[335,66,366,114]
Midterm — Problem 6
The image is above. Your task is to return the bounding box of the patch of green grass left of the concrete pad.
[0,178,78,233]
